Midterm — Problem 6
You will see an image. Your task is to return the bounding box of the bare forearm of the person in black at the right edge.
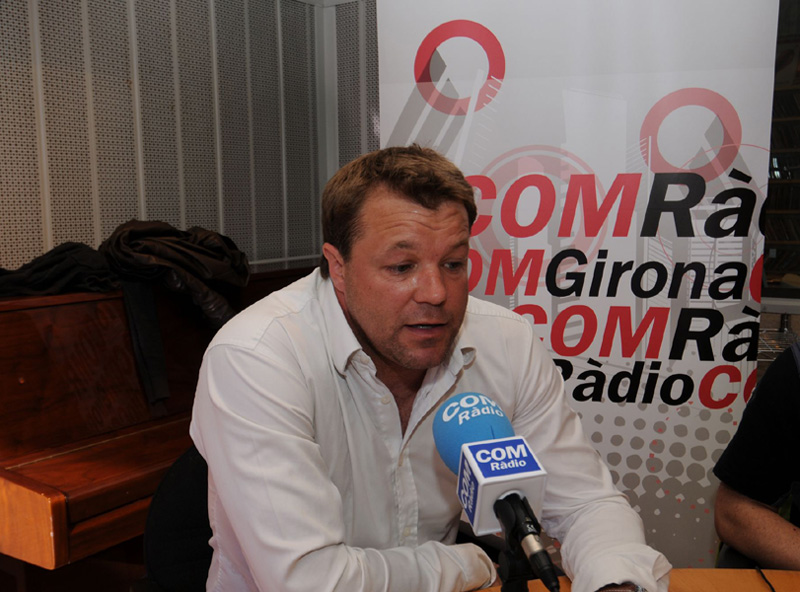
[714,483,800,569]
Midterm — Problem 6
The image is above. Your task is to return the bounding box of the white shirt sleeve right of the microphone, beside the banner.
[512,328,671,592]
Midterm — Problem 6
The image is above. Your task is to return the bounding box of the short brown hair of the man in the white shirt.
[320,144,477,278]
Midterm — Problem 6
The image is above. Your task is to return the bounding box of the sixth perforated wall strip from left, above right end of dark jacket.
[216,0,253,253]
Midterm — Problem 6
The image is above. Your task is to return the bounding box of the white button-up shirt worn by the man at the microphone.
[191,271,669,592]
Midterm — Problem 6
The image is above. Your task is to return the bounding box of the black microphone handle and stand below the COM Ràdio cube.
[494,493,560,592]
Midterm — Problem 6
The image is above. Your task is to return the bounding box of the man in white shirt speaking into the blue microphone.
[191,146,670,592]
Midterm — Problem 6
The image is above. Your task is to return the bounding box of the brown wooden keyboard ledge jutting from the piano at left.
[0,415,191,569]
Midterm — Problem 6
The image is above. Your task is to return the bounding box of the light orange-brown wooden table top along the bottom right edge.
[489,569,800,592]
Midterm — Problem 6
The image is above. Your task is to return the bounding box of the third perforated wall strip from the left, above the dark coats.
[88,0,138,240]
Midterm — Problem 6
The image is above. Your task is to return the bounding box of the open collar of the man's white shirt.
[319,277,477,375]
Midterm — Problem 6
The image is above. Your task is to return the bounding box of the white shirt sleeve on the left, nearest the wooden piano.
[191,332,495,592]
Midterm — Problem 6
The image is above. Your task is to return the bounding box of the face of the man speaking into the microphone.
[323,188,469,384]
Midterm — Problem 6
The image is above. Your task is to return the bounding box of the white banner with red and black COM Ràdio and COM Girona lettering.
[377,0,778,567]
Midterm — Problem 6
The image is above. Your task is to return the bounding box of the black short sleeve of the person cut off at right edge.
[714,348,800,505]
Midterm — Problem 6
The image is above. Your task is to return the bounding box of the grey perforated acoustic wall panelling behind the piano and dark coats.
[0,0,378,270]
